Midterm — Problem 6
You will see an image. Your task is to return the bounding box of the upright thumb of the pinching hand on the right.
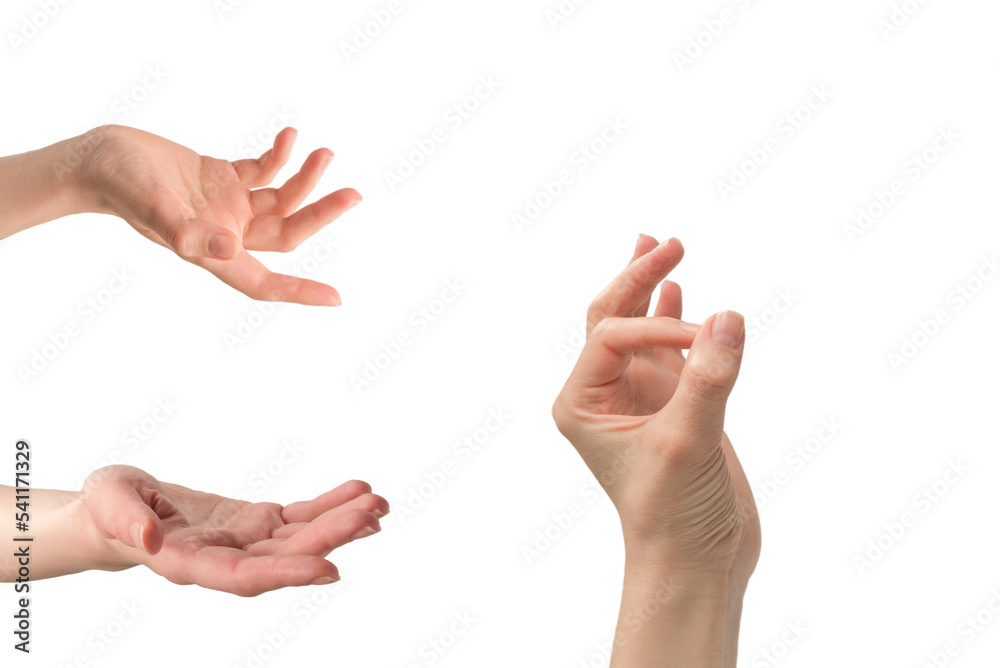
[656,311,745,444]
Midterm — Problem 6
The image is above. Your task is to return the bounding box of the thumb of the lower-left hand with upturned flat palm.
[91,480,163,554]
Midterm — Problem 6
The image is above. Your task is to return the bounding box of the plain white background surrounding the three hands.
[0,0,1000,668]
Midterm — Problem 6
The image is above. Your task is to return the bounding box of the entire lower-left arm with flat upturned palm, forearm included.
[0,466,389,596]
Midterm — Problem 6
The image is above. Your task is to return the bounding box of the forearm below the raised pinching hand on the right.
[611,562,746,668]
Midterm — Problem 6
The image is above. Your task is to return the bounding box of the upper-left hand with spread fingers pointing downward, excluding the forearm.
[75,125,361,306]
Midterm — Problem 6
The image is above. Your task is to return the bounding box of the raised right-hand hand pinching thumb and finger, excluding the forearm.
[552,236,760,586]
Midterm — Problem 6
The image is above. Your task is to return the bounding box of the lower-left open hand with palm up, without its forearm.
[77,466,389,596]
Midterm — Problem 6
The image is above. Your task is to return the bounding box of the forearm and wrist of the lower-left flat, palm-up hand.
[0,485,128,582]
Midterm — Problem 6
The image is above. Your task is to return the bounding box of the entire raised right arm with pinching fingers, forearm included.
[552,235,760,668]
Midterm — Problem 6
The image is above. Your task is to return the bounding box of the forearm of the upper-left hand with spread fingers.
[0,128,100,239]
